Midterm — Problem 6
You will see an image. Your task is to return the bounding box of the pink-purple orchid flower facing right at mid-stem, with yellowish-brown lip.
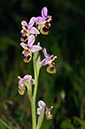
[40,48,57,74]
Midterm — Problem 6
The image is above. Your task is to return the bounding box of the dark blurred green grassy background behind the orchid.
[0,0,85,129]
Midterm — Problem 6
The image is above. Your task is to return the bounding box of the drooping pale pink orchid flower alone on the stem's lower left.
[18,75,35,95]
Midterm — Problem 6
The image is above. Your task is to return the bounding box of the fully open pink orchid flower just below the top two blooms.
[20,35,42,63]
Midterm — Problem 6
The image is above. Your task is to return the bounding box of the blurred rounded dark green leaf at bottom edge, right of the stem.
[60,119,76,129]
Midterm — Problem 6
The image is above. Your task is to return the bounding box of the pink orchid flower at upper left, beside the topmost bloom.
[21,17,40,42]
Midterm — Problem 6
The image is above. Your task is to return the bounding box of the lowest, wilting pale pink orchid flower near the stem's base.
[37,100,53,120]
